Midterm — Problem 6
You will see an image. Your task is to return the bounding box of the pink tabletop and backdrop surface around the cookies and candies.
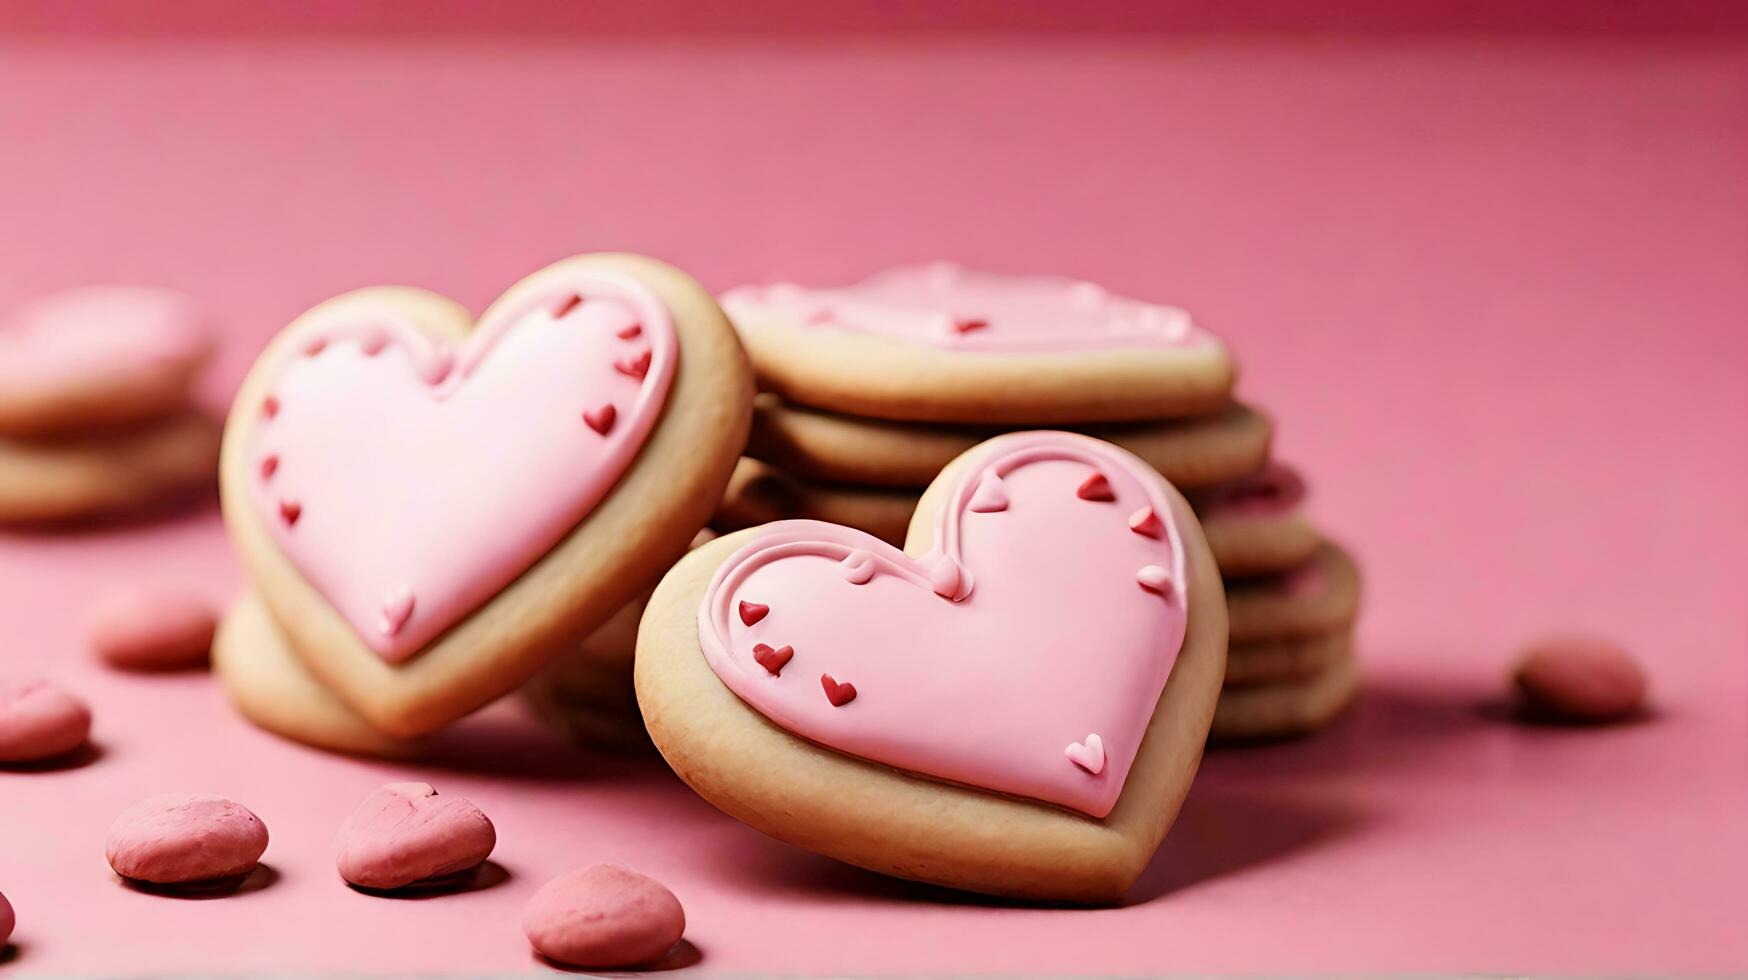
[0,26,1748,975]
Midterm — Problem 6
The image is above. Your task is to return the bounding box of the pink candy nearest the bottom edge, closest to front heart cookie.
[523,865,685,968]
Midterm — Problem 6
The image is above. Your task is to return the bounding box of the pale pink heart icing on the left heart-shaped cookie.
[248,271,678,662]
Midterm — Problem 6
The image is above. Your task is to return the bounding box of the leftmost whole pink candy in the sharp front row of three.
[107,793,267,884]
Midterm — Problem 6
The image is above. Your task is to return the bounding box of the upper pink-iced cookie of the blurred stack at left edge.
[0,286,212,437]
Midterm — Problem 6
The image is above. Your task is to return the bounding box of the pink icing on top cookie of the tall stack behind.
[722,262,1218,351]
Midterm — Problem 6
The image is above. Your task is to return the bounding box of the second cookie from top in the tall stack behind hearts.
[746,393,1273,489]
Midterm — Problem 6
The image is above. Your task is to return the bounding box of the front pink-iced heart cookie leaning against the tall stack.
[636,431,1225,903]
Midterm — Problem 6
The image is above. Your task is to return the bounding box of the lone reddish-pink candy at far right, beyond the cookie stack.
[1514,636,1645,721]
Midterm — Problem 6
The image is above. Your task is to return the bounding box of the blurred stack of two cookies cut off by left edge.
[0,286,219,524]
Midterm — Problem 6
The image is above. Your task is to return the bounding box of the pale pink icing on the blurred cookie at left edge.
[0,286,212,388]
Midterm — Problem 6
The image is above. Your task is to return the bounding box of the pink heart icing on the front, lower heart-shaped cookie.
[699,431,1187,818]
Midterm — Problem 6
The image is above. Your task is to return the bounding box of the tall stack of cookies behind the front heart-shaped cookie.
[713,264,1358,741]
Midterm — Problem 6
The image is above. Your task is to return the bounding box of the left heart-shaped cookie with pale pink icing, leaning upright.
[220,255,752,735]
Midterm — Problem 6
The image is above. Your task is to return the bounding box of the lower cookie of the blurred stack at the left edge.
[0,409,219,522]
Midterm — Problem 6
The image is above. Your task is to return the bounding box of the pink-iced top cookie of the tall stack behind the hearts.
[722,262,1234,424]
